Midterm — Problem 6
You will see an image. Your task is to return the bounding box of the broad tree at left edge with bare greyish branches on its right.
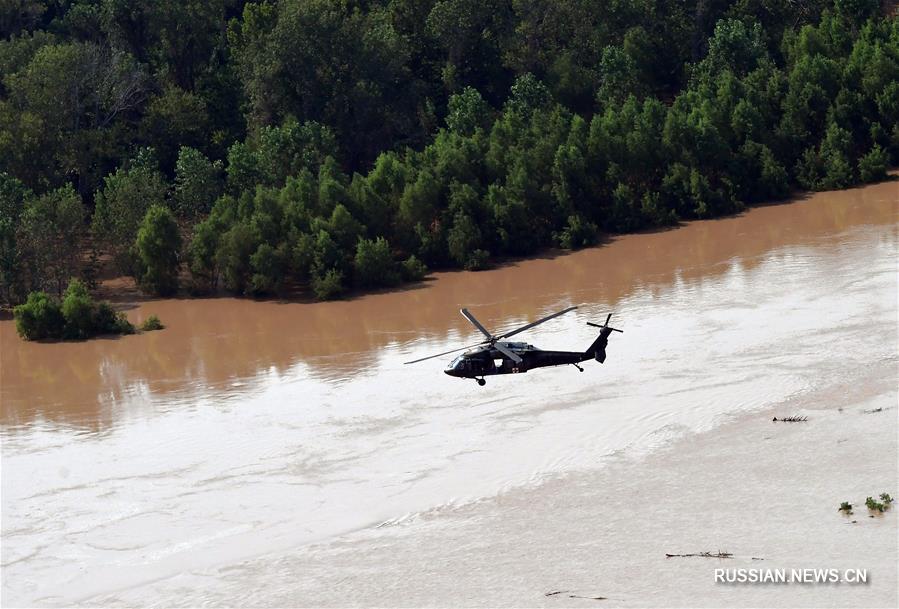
[0,42,147,195]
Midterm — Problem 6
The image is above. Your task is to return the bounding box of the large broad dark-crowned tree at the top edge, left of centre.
[229,0,416,167]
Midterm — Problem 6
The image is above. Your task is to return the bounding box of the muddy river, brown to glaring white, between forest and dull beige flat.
[0,182,899,606]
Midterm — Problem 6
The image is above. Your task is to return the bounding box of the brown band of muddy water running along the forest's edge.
[0,177,897,428]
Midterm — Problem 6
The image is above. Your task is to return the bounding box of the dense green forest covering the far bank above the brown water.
[0,0,899,304]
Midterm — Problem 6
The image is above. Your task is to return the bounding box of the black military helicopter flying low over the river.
[405,307,624,387]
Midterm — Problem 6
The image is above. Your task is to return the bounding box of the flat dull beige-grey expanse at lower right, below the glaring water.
[84,358,899,607]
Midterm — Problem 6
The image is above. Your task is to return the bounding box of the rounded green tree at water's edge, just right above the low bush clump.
[134,204,181,296]
